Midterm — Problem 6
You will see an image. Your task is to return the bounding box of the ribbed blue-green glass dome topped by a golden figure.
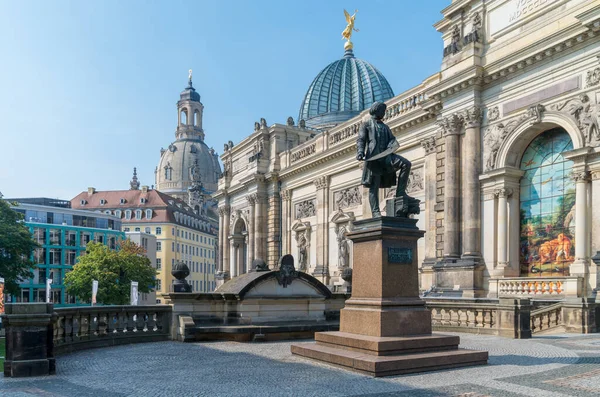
[299,49,394,129]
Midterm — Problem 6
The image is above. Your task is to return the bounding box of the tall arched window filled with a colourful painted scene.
[519,128,575,277]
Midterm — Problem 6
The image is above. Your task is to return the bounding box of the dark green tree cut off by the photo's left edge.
[0,199,39,294]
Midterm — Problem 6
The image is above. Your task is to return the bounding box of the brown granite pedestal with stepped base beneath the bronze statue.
[291,216,488,376]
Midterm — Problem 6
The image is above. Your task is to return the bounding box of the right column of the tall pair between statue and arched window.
[462,106,482,262]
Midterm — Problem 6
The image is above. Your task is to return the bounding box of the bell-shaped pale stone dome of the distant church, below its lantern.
[156,138,221,196]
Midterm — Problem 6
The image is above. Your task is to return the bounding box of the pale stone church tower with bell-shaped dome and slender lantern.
[154,70,221,208]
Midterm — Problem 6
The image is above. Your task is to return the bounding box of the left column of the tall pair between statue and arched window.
[440,115,462,259]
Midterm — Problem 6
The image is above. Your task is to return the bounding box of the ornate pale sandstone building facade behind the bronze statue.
[213,0,600,299]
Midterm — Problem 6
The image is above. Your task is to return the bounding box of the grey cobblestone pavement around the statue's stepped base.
[0,334,600,397]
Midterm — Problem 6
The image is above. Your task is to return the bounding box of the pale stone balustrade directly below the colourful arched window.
[490,277,583,299]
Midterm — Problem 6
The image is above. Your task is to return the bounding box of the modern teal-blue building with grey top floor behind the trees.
[9,200,125,307]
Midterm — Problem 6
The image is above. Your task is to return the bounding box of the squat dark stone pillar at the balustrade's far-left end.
[2,303,56,377]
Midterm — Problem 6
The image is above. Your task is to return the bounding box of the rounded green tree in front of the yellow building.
[65,239,156,305]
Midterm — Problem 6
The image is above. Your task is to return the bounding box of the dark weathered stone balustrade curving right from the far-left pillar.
[53,305,172,354]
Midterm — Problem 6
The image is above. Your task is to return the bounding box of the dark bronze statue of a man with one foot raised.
[356,102,419,217]
